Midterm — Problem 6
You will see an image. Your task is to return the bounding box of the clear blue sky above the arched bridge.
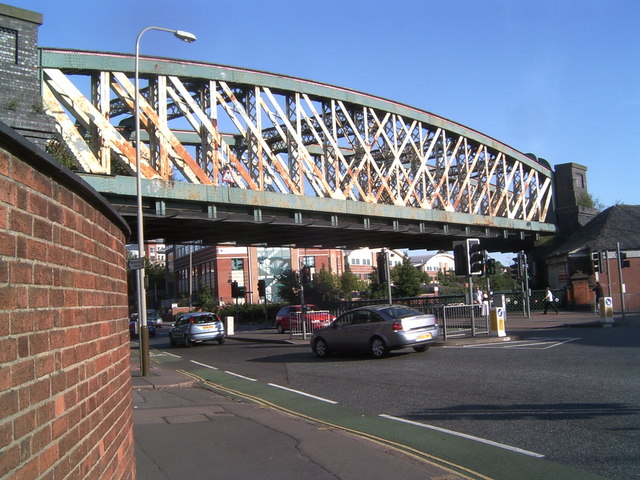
[6,0,640,207]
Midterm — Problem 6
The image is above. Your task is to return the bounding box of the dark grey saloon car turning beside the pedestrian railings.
[311,305,440,358]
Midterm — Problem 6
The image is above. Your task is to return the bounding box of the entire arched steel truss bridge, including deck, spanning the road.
[40,49,556,251]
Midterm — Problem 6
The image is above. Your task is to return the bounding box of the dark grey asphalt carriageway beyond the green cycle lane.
[152,326,640,479]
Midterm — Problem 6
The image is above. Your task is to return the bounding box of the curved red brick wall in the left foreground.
[0,144,135,480]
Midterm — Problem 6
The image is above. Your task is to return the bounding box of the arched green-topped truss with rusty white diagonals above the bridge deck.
[41,49,555,248]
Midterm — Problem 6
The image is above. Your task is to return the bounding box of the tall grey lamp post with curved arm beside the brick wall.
[134,26,196,376]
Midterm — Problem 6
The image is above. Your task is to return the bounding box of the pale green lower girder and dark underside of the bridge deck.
[83,175,539,251]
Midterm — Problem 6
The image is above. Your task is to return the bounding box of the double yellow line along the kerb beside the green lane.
[178,370,493,480]
